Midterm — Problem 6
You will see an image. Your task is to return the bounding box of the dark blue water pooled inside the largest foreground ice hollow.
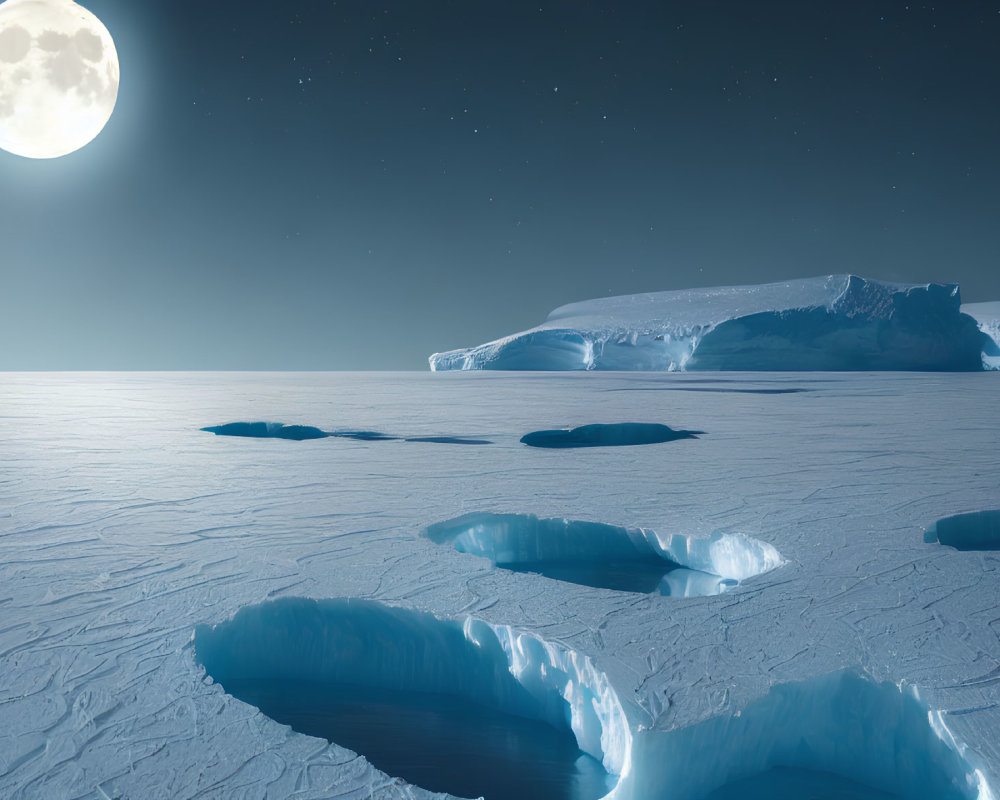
[224,680,614,800]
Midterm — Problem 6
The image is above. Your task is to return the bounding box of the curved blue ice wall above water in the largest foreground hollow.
[194,598,631,794]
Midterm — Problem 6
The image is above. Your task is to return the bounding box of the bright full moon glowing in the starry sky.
[0,0,118,158]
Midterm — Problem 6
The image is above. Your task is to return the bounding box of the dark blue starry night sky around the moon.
[0,0,1000,369]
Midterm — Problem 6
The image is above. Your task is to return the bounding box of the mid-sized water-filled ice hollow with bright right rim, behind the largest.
[427,513,781,597]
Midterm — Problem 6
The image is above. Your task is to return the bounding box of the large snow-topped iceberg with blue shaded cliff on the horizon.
[430,275,1000,372]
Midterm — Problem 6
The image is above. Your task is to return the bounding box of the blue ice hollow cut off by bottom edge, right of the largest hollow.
[614,670,993,800]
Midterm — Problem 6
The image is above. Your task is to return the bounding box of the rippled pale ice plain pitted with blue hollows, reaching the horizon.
[0,372,1000,800]
